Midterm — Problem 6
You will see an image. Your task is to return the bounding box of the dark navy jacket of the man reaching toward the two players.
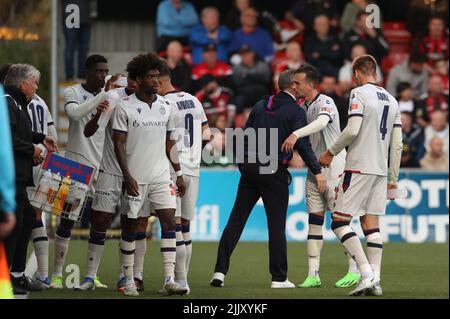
[245,92,321,175]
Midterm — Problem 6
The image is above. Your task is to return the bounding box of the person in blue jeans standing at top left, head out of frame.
[61,0,91,81]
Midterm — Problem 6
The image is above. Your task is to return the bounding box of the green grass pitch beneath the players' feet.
[30,240,449,299]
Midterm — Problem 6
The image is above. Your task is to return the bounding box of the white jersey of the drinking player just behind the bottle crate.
[64,84,105,169]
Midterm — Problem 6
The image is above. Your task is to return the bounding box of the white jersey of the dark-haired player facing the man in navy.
[301,94,347,180]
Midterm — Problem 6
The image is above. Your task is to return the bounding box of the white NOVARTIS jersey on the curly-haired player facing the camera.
[113,94,175,184]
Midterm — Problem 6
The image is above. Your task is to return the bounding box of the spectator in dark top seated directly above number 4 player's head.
[343,11,389,64]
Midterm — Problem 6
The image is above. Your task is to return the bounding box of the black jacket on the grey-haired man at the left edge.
[5,86,45,186]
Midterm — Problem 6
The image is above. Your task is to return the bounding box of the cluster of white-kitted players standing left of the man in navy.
[22,54,209,296]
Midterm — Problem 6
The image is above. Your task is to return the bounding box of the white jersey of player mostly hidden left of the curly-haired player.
[100,88,132,176]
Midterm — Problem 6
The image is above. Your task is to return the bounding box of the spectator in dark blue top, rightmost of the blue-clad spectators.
[230,8,273,62]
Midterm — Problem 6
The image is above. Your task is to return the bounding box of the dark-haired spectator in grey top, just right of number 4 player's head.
[386,54,429,99]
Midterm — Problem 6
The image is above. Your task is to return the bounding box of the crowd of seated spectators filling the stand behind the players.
[156,0,449,170]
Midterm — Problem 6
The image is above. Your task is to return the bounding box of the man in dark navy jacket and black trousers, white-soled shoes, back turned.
[211,71,325,288]
